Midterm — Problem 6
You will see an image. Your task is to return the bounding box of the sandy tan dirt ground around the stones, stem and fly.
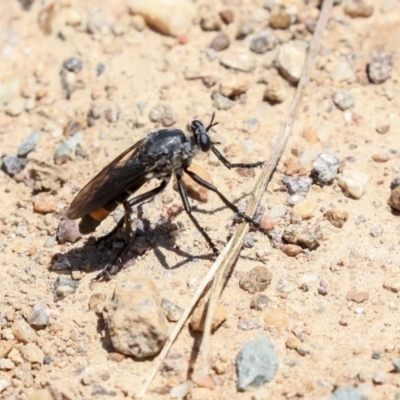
[0,0,400,399]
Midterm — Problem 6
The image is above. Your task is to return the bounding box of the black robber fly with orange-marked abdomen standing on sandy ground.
[67,114,268,280]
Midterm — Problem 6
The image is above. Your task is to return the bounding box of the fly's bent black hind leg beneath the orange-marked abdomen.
[93,176,171,281]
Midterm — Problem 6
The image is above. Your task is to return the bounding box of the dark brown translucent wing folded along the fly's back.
[67,139,153,219]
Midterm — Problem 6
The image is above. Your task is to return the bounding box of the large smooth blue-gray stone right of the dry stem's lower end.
[236,336,279,390]
